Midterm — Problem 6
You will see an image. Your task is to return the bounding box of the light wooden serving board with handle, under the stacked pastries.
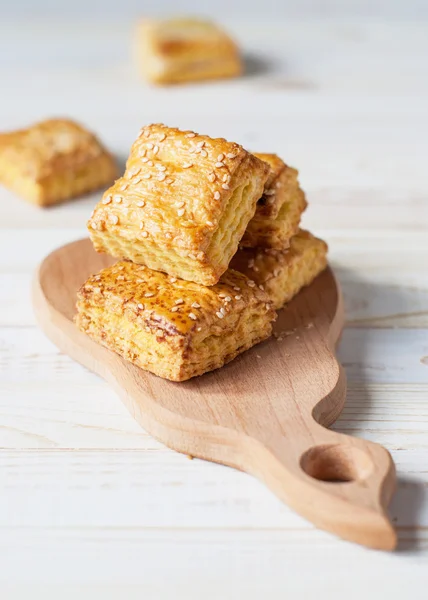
[33,239,396,549]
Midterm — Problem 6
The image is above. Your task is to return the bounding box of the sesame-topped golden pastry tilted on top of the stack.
[88,125,268,285]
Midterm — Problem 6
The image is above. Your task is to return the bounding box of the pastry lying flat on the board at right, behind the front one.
[230,229,327,309]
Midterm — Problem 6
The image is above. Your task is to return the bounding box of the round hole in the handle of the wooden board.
[300,444,373,483]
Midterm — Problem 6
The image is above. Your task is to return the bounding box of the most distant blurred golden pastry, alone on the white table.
[137,19,242,84]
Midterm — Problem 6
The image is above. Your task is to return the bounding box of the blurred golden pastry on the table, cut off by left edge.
[0,119,118,206]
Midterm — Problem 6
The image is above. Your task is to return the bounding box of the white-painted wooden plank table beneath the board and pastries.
[0,21,428,600]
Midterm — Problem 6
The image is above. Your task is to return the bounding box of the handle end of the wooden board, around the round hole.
[261,394,397,550]
